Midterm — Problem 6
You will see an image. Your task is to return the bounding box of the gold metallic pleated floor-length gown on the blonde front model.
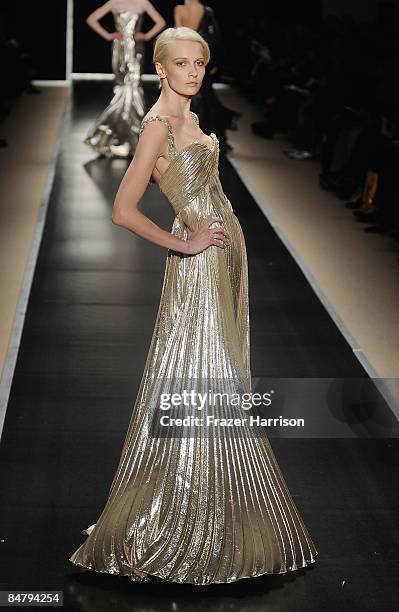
[69,112,318,585]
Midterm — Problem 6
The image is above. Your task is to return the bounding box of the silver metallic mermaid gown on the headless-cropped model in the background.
[84,10,145,157]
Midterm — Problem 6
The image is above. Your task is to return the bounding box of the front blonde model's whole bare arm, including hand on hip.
[112,121,229,255]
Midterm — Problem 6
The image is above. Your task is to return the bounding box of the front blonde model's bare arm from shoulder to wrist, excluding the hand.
[112,121,187,253]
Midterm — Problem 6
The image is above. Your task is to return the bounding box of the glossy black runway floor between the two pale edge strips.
[0,83,399,612]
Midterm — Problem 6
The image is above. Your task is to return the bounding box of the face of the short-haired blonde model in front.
[157,40,205,96]
